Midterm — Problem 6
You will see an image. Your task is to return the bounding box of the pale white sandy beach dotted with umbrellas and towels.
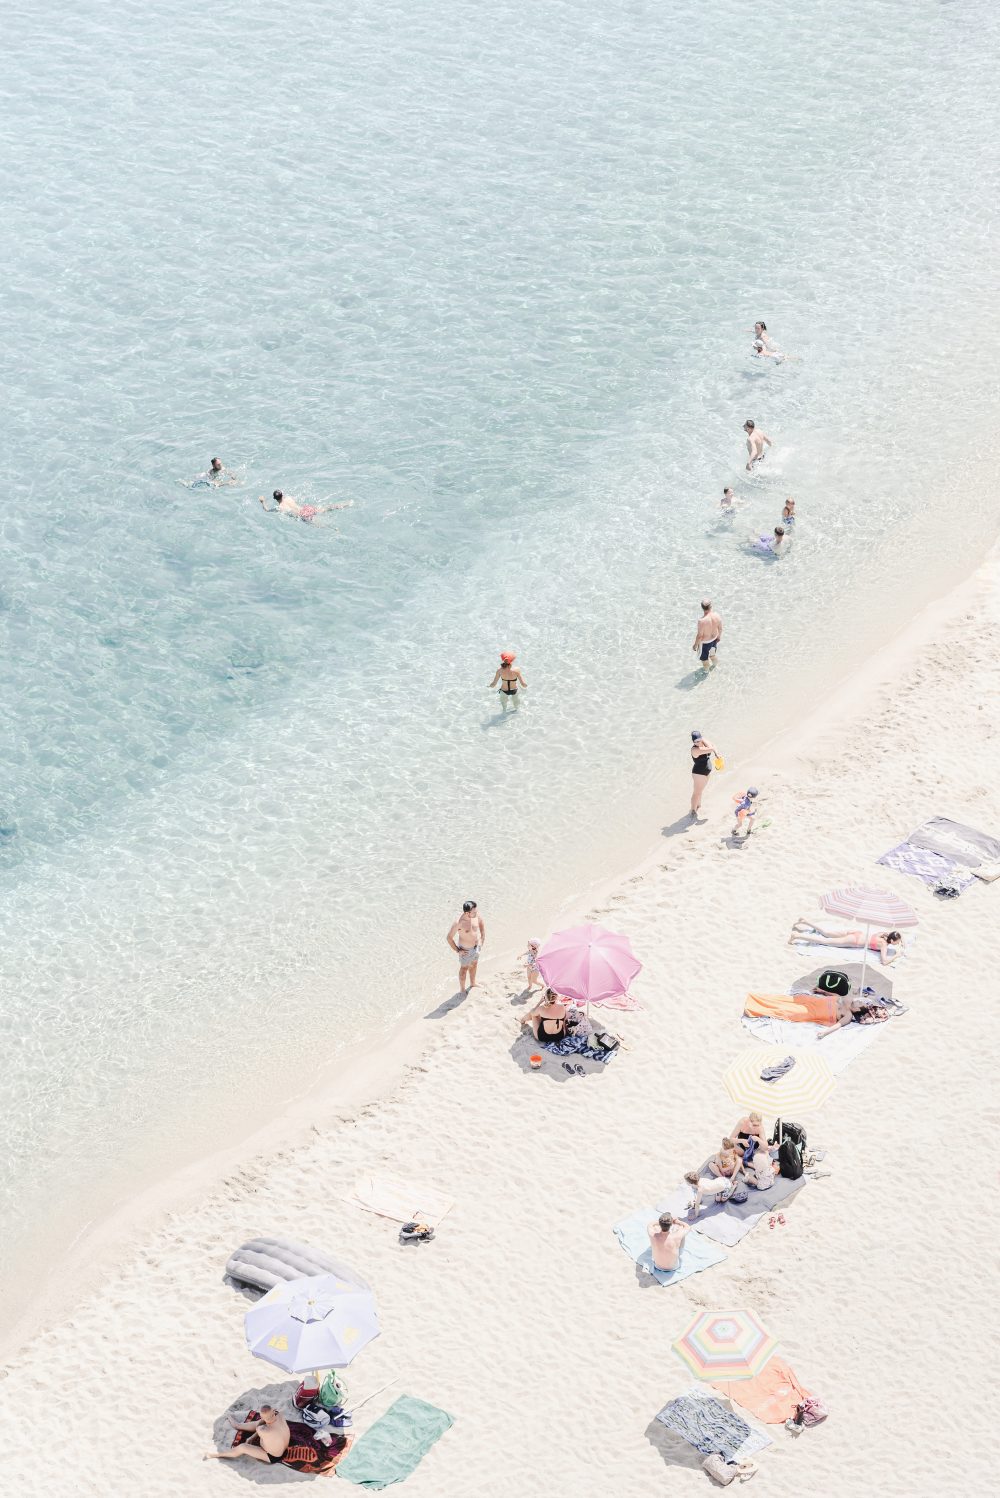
[0,554,1000,1498]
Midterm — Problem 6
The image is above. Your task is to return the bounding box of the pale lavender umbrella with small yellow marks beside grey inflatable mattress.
[243,1275,379,1374]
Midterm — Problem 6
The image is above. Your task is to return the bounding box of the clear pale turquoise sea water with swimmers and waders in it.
[0,0,1000,1312]
